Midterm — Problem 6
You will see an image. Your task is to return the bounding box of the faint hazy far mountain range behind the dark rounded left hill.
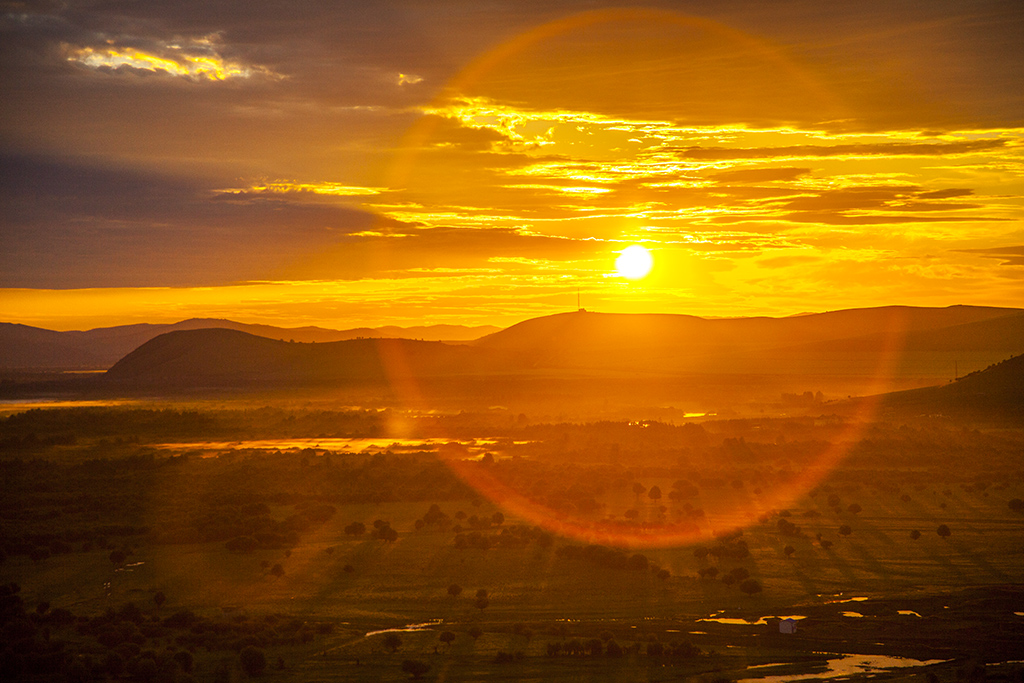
[0,318,499,370]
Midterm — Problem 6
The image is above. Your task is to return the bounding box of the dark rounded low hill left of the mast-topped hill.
[104,329,491,389]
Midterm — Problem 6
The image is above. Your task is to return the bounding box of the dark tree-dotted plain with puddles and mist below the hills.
[0,408,1024,683]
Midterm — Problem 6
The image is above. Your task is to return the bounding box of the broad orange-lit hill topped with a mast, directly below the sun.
[474,306,1024,379]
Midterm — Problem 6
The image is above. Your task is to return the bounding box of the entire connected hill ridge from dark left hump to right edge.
[88,306,1024,404]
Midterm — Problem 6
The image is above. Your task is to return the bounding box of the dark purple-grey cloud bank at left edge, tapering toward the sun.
[0,155,393,289]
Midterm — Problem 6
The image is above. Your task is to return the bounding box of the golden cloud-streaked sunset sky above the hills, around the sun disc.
[0,0,1024,330]
